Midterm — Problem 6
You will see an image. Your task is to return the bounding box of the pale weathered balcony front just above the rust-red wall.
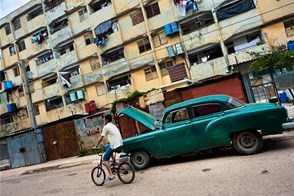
[190,57,227,81]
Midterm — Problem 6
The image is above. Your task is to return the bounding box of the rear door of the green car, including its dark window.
[191,103,231,149]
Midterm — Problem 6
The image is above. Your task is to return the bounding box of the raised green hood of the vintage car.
[121,106,156,130]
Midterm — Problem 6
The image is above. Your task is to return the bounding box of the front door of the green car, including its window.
[157,108,198,158]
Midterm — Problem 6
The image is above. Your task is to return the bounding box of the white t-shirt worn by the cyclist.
[101,123,122,149]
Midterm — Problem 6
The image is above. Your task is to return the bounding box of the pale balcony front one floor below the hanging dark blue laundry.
[102,58,130,80]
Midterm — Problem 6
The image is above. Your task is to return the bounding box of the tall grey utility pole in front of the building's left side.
[17,60,37,130]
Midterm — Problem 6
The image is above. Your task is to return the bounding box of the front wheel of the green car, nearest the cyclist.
[131,150,150,170]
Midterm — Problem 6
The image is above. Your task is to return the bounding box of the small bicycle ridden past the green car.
[91,148,135,186]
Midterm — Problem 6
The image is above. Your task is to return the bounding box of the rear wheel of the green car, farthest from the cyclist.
[232,131,263,155]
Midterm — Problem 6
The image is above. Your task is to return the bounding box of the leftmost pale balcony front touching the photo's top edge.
[45,0,66,24]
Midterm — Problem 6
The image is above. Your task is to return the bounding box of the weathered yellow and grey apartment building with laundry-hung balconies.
[0,0,294,135]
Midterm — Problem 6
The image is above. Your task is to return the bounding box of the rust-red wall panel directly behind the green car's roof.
[181,74,247,102]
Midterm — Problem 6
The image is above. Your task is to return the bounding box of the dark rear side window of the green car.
[192,103,221,117]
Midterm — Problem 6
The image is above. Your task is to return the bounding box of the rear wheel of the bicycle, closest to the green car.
[117,162,135,184]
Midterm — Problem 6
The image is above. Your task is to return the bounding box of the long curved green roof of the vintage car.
[164,95,230,113]
